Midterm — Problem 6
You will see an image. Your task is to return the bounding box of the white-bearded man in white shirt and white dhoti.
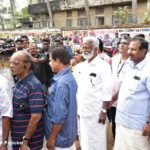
[74,37,112,150]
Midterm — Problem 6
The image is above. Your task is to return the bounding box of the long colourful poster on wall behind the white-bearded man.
[62,28,150,46]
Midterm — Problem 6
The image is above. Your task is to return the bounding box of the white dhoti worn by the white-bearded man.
[80,115,107,150]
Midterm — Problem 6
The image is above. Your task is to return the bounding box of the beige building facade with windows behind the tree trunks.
[28,0,150,29]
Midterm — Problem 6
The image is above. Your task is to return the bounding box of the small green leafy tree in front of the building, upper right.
[114,6,128,25]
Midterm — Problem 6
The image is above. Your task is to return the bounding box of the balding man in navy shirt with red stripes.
[10,51,44,150]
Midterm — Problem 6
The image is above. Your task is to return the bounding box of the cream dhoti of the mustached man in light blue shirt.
[114,124,150,150]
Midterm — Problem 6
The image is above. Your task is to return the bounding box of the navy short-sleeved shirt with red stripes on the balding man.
[11,73,44,150]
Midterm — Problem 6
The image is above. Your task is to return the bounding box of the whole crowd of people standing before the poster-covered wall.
[0,34,150,150]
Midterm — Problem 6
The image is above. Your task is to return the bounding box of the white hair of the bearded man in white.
[83,36,99,48]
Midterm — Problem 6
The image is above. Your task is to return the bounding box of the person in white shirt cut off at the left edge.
[0,75,13,150]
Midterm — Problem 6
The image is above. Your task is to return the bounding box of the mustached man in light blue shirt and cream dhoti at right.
[114,37,150,150]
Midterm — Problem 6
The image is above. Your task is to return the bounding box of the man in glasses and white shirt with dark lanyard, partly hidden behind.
[109,36,130,139]
